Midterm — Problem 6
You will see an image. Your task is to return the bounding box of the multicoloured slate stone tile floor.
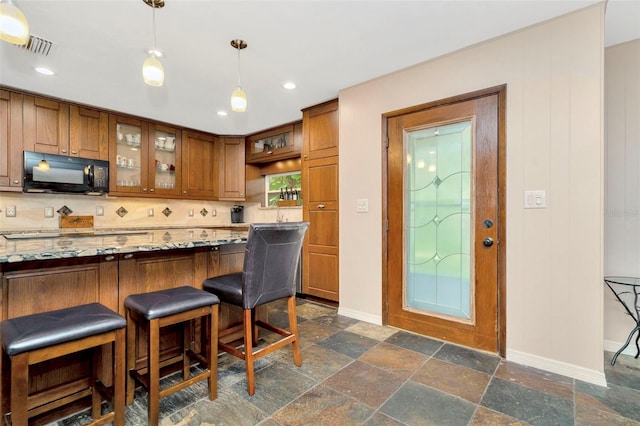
[58,300,640,426]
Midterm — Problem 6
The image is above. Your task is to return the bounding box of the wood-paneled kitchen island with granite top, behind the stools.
[0,225,250,421]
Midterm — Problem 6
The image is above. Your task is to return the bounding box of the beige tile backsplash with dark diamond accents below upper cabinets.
[0,192,302,231]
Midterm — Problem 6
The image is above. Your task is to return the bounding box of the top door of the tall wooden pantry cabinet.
[302,101,339,160]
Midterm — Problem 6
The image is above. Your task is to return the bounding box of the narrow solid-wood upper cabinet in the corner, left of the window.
[216,137,245,201]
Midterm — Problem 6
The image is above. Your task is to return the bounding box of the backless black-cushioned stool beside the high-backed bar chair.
[124,286,220,425]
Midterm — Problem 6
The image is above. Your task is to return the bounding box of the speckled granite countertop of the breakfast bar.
[0,225,247,263]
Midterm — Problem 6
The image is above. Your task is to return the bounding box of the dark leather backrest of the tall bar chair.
[242,222,309,309]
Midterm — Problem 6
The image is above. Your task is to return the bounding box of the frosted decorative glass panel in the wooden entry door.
[404,120,474,322]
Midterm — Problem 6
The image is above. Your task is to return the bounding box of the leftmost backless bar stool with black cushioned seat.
[1,303,126,425]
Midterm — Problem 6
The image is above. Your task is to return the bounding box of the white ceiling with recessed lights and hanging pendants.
[0,0,640,135]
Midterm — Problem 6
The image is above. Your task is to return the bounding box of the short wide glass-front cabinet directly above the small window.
[246,122,302,163]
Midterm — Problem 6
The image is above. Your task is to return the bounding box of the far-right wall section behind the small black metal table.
[604,40,640,355]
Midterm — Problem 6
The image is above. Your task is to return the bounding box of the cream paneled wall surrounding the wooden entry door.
[340,4,604,384]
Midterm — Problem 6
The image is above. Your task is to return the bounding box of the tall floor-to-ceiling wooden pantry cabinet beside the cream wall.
[302,99,339,302]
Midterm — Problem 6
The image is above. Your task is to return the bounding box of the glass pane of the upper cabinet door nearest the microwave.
[116,123,144,192]
